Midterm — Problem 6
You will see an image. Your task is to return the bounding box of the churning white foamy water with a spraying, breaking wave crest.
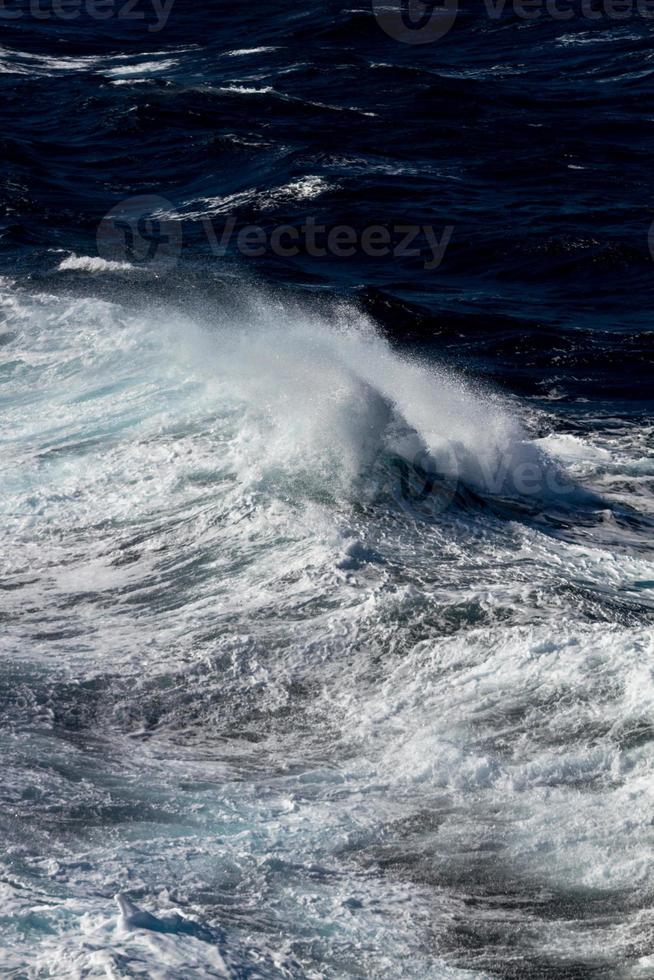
[0,282,654,980]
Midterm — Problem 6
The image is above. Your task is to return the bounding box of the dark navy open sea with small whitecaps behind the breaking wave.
[2,3,654,402]
